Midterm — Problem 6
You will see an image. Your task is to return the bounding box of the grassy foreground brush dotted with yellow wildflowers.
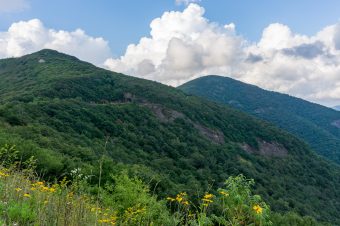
[0,146,326,226]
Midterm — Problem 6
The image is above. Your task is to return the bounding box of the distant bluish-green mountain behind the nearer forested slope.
[179,76,340,163]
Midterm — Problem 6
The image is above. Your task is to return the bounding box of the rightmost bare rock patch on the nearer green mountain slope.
[240,140,288,157]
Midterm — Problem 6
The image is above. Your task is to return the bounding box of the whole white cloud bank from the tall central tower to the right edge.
[105,4,340,105]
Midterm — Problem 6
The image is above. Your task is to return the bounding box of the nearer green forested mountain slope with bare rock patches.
[0,50,340,224]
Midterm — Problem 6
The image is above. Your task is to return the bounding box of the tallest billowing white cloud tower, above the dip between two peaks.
[105,4,245,85]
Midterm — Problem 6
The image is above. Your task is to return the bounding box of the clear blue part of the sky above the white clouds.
[0,0,340,55]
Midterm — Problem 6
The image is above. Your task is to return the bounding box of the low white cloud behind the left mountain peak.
[0,19,111,65]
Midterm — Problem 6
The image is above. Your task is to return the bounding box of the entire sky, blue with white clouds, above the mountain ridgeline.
[0,0,340,106]
